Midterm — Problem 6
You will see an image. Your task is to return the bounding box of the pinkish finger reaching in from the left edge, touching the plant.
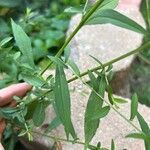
[0,83,32,106]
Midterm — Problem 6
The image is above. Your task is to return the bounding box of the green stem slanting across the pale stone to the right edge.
[68,42,150,83]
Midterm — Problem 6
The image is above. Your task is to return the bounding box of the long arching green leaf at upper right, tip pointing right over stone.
[86,9,147,34]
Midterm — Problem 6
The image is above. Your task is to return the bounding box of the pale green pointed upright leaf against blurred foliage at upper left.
[11,20,35,68]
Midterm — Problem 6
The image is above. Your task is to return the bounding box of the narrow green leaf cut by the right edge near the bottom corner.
[137,113,150,150]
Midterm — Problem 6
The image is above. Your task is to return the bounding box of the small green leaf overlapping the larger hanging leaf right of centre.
[91,106,110,121]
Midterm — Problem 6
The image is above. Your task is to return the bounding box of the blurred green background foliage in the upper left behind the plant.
[0,0,85,88]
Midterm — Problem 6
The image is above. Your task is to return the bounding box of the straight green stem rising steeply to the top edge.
[40,0,104,75]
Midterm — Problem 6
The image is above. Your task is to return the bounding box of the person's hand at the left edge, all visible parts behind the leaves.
[0,83,32,150]
